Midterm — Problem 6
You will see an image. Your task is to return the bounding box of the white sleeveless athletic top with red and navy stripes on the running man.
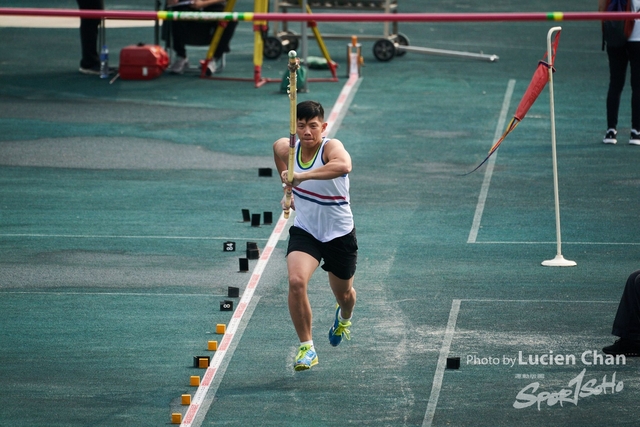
[293,138,353,242]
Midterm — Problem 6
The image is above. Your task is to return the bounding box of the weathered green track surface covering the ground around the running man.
[0,0,640,427]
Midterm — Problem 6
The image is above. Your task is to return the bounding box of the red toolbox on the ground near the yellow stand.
[118,43,169,80]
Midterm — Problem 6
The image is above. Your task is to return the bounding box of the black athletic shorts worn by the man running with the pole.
[287,227,358,280]
